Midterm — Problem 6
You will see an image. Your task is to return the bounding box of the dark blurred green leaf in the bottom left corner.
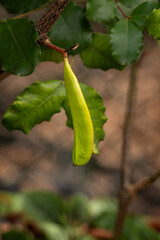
[2,230,34,240]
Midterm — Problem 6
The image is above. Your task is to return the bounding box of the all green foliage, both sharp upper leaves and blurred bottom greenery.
[0,0,160,234]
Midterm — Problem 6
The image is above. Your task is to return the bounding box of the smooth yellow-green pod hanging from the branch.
[64,58,94,166]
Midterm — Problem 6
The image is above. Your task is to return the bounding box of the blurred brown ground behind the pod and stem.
[0,3,160,216]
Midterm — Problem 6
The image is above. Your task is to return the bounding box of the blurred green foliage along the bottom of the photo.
[0,192,160,240]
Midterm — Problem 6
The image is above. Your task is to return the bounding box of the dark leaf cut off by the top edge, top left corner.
[0,0,49,13]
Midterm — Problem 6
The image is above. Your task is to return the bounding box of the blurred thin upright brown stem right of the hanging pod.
[114,55,143,240]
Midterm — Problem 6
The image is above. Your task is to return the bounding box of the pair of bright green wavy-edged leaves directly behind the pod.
[2,80,106,153]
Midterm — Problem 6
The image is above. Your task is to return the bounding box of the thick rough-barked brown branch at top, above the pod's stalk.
[36,0,70,41]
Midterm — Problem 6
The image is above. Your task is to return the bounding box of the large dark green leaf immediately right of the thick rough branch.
[49,2,92,54]
